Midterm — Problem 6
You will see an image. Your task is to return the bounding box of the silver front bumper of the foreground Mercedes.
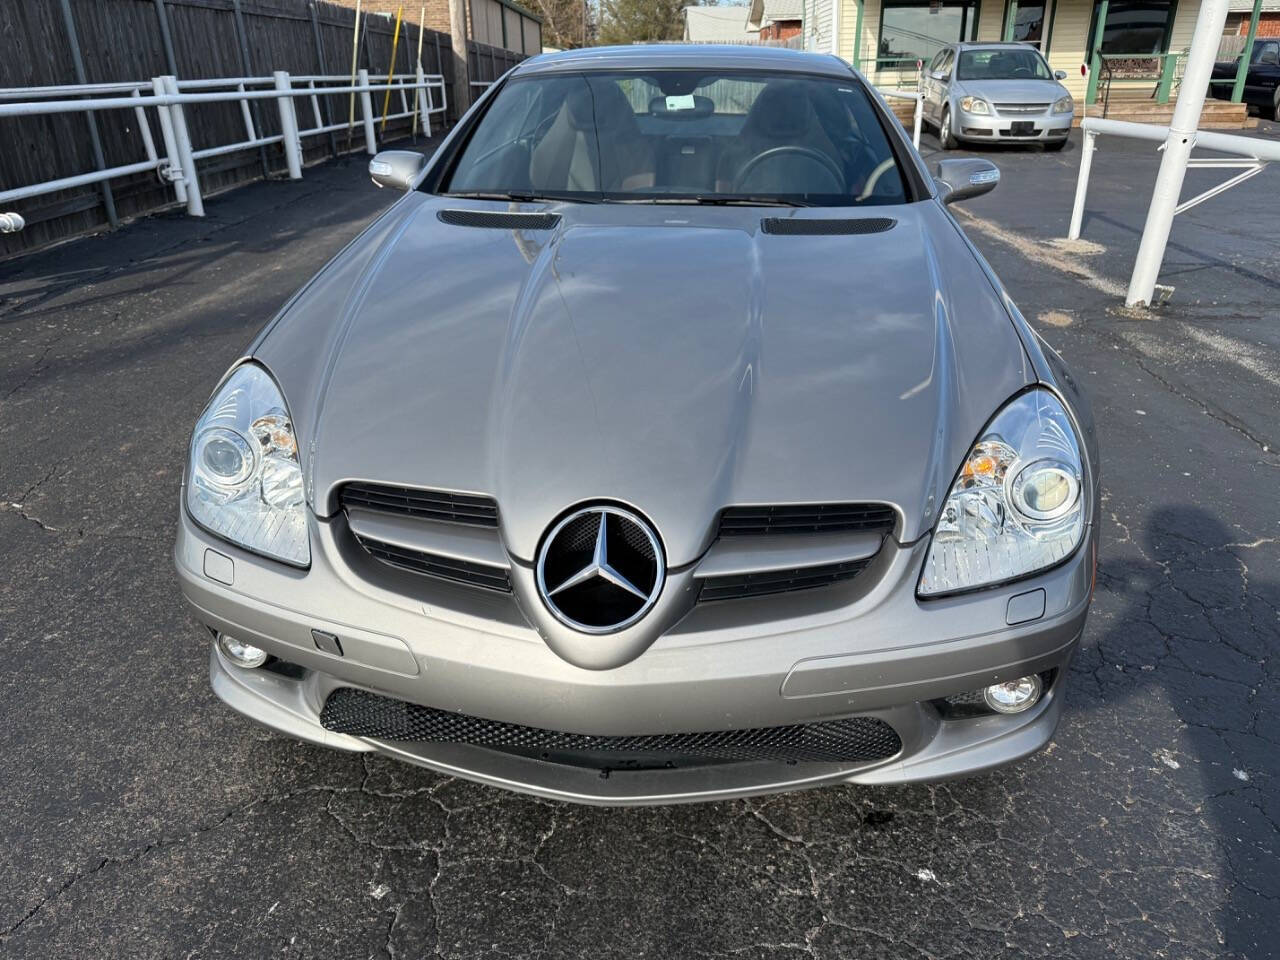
[175,513,1094,804]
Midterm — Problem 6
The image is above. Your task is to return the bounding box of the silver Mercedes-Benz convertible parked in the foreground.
[175,46,1098,804]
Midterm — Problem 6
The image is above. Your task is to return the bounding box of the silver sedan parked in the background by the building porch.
[920,44,1075,150]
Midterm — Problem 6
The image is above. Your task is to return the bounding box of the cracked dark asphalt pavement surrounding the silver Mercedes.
[0,127,1280,960]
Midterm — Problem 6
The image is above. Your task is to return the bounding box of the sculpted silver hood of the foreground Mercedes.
[253,195,1033,567]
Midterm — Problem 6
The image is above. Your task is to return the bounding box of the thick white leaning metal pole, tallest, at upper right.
[1125,0,1228,306]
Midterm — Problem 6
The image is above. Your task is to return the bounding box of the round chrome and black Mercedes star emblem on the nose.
[538,506,666,634]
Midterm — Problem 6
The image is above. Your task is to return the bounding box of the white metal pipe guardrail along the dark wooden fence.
[0,67,448,232]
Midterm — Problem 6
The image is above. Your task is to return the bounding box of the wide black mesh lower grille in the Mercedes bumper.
[320,687,902,769]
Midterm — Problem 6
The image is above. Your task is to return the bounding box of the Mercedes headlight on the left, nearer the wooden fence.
[187,364,311,567]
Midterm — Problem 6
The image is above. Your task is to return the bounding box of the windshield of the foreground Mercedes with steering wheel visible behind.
[442,69,906,206]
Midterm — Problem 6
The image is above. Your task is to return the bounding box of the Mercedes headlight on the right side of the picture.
[919,389,1084,596]
